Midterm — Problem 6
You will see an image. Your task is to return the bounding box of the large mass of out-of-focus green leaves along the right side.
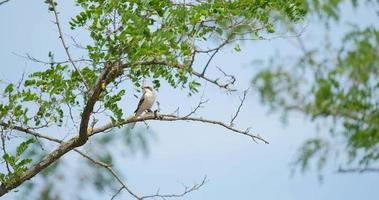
[253,1,379,171]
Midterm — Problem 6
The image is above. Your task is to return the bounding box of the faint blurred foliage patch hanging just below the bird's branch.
[80,128,154,193]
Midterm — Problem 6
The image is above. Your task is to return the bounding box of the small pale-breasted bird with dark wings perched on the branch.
[131,85,156,128]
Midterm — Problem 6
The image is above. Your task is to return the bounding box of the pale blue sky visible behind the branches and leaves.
[0,0,379,200]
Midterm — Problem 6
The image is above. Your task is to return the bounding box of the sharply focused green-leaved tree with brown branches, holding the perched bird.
[0,0,305,199]
